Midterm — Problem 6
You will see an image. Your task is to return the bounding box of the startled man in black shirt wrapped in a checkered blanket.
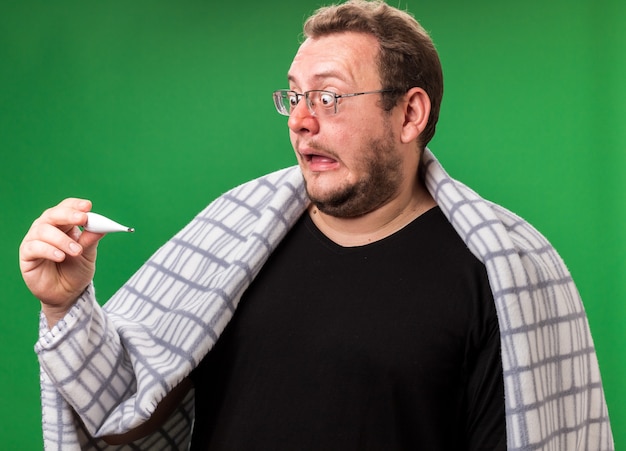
[20,1,612,450]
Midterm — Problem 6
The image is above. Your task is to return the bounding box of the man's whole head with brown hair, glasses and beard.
[274,1,441,218]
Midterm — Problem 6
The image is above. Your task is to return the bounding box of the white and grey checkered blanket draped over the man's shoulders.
[35,150,614,451]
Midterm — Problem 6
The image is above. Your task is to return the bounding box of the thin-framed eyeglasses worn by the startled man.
[274,89,395,116]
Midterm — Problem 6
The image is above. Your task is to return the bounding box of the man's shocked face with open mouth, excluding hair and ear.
[288,33,414,217]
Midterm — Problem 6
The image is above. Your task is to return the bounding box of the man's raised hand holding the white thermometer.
[20,199,104,326]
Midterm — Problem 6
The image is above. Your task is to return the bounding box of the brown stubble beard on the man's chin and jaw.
[305,128,402,218]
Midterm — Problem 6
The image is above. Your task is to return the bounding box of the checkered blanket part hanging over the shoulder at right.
[425,152,613,451]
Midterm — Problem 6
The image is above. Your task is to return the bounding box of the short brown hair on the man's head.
[304,0,443,148]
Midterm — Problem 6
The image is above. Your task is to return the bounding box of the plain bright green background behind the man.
[0,0,626,450]
